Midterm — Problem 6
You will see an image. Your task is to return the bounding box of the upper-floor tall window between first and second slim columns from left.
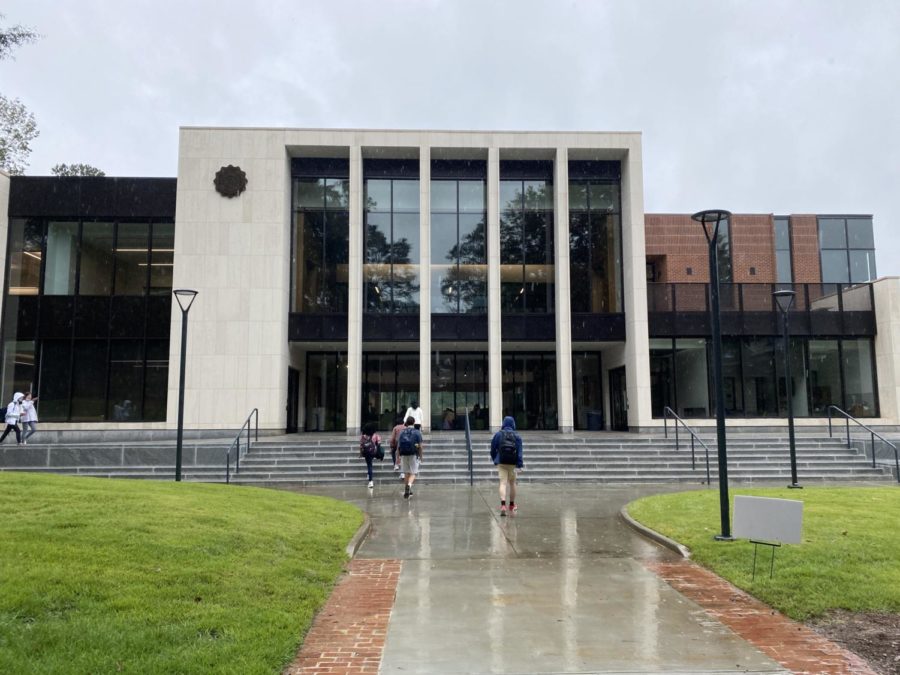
[363,178,420,314]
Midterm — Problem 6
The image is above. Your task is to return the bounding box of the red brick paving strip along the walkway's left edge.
[284,560,401,675]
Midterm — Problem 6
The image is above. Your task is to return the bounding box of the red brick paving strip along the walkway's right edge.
[645,560,877,675]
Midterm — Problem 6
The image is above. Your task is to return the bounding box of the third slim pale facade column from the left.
[487,148,503,431]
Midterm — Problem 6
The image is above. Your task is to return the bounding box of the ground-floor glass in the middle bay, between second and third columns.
[432,351,490,431]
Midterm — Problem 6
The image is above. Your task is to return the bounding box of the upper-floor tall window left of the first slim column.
[291,174,350,314]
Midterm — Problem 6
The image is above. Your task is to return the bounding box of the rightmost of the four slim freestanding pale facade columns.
[553,148,575,433]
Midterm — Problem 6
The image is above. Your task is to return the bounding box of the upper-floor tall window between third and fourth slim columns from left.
[500,169,554,314]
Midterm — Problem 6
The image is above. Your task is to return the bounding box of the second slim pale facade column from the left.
[419,145,431,431]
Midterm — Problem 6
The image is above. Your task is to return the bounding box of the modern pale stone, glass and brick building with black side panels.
[0,128,900,434]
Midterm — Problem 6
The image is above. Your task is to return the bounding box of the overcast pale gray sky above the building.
[0,0,900,276]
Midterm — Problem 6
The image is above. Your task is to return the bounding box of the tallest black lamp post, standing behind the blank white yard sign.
[691,209,732,541]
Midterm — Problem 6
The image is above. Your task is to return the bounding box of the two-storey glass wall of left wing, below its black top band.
[2,218,175,422]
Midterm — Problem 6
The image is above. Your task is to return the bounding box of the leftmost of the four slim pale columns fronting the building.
[347,145,363,436]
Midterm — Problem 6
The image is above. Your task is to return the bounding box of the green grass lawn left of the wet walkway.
[0,473,363,674]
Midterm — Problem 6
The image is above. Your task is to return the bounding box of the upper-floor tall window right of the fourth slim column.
[569,180,622,313]
